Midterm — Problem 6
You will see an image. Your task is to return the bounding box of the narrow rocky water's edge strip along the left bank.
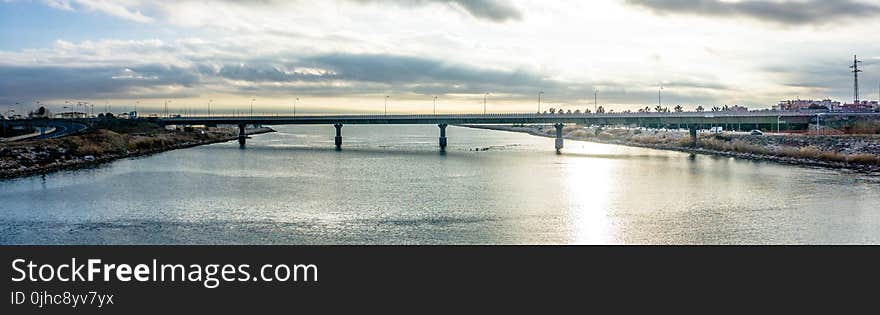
[0,127,275,180]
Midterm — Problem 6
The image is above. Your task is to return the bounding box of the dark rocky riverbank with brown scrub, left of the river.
[0,123,274,178]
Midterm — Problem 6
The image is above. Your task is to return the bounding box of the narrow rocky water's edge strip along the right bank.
[460,125,880,175]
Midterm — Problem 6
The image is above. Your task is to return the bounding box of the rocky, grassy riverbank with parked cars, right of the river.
[466,125,880,173]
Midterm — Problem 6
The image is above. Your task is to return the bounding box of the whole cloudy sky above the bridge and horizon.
[0,0,880,113]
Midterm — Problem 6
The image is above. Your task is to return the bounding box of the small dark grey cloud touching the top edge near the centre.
[351,0,522,22]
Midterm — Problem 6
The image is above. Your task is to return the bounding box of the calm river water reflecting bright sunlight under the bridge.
[0,125,880,244]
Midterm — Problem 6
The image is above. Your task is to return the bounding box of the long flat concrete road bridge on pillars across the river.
[157,111,832,152]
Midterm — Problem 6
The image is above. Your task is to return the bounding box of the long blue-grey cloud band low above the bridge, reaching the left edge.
[0,54,726,104]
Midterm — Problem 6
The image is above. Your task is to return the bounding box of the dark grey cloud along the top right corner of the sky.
[626,0,880,25]
